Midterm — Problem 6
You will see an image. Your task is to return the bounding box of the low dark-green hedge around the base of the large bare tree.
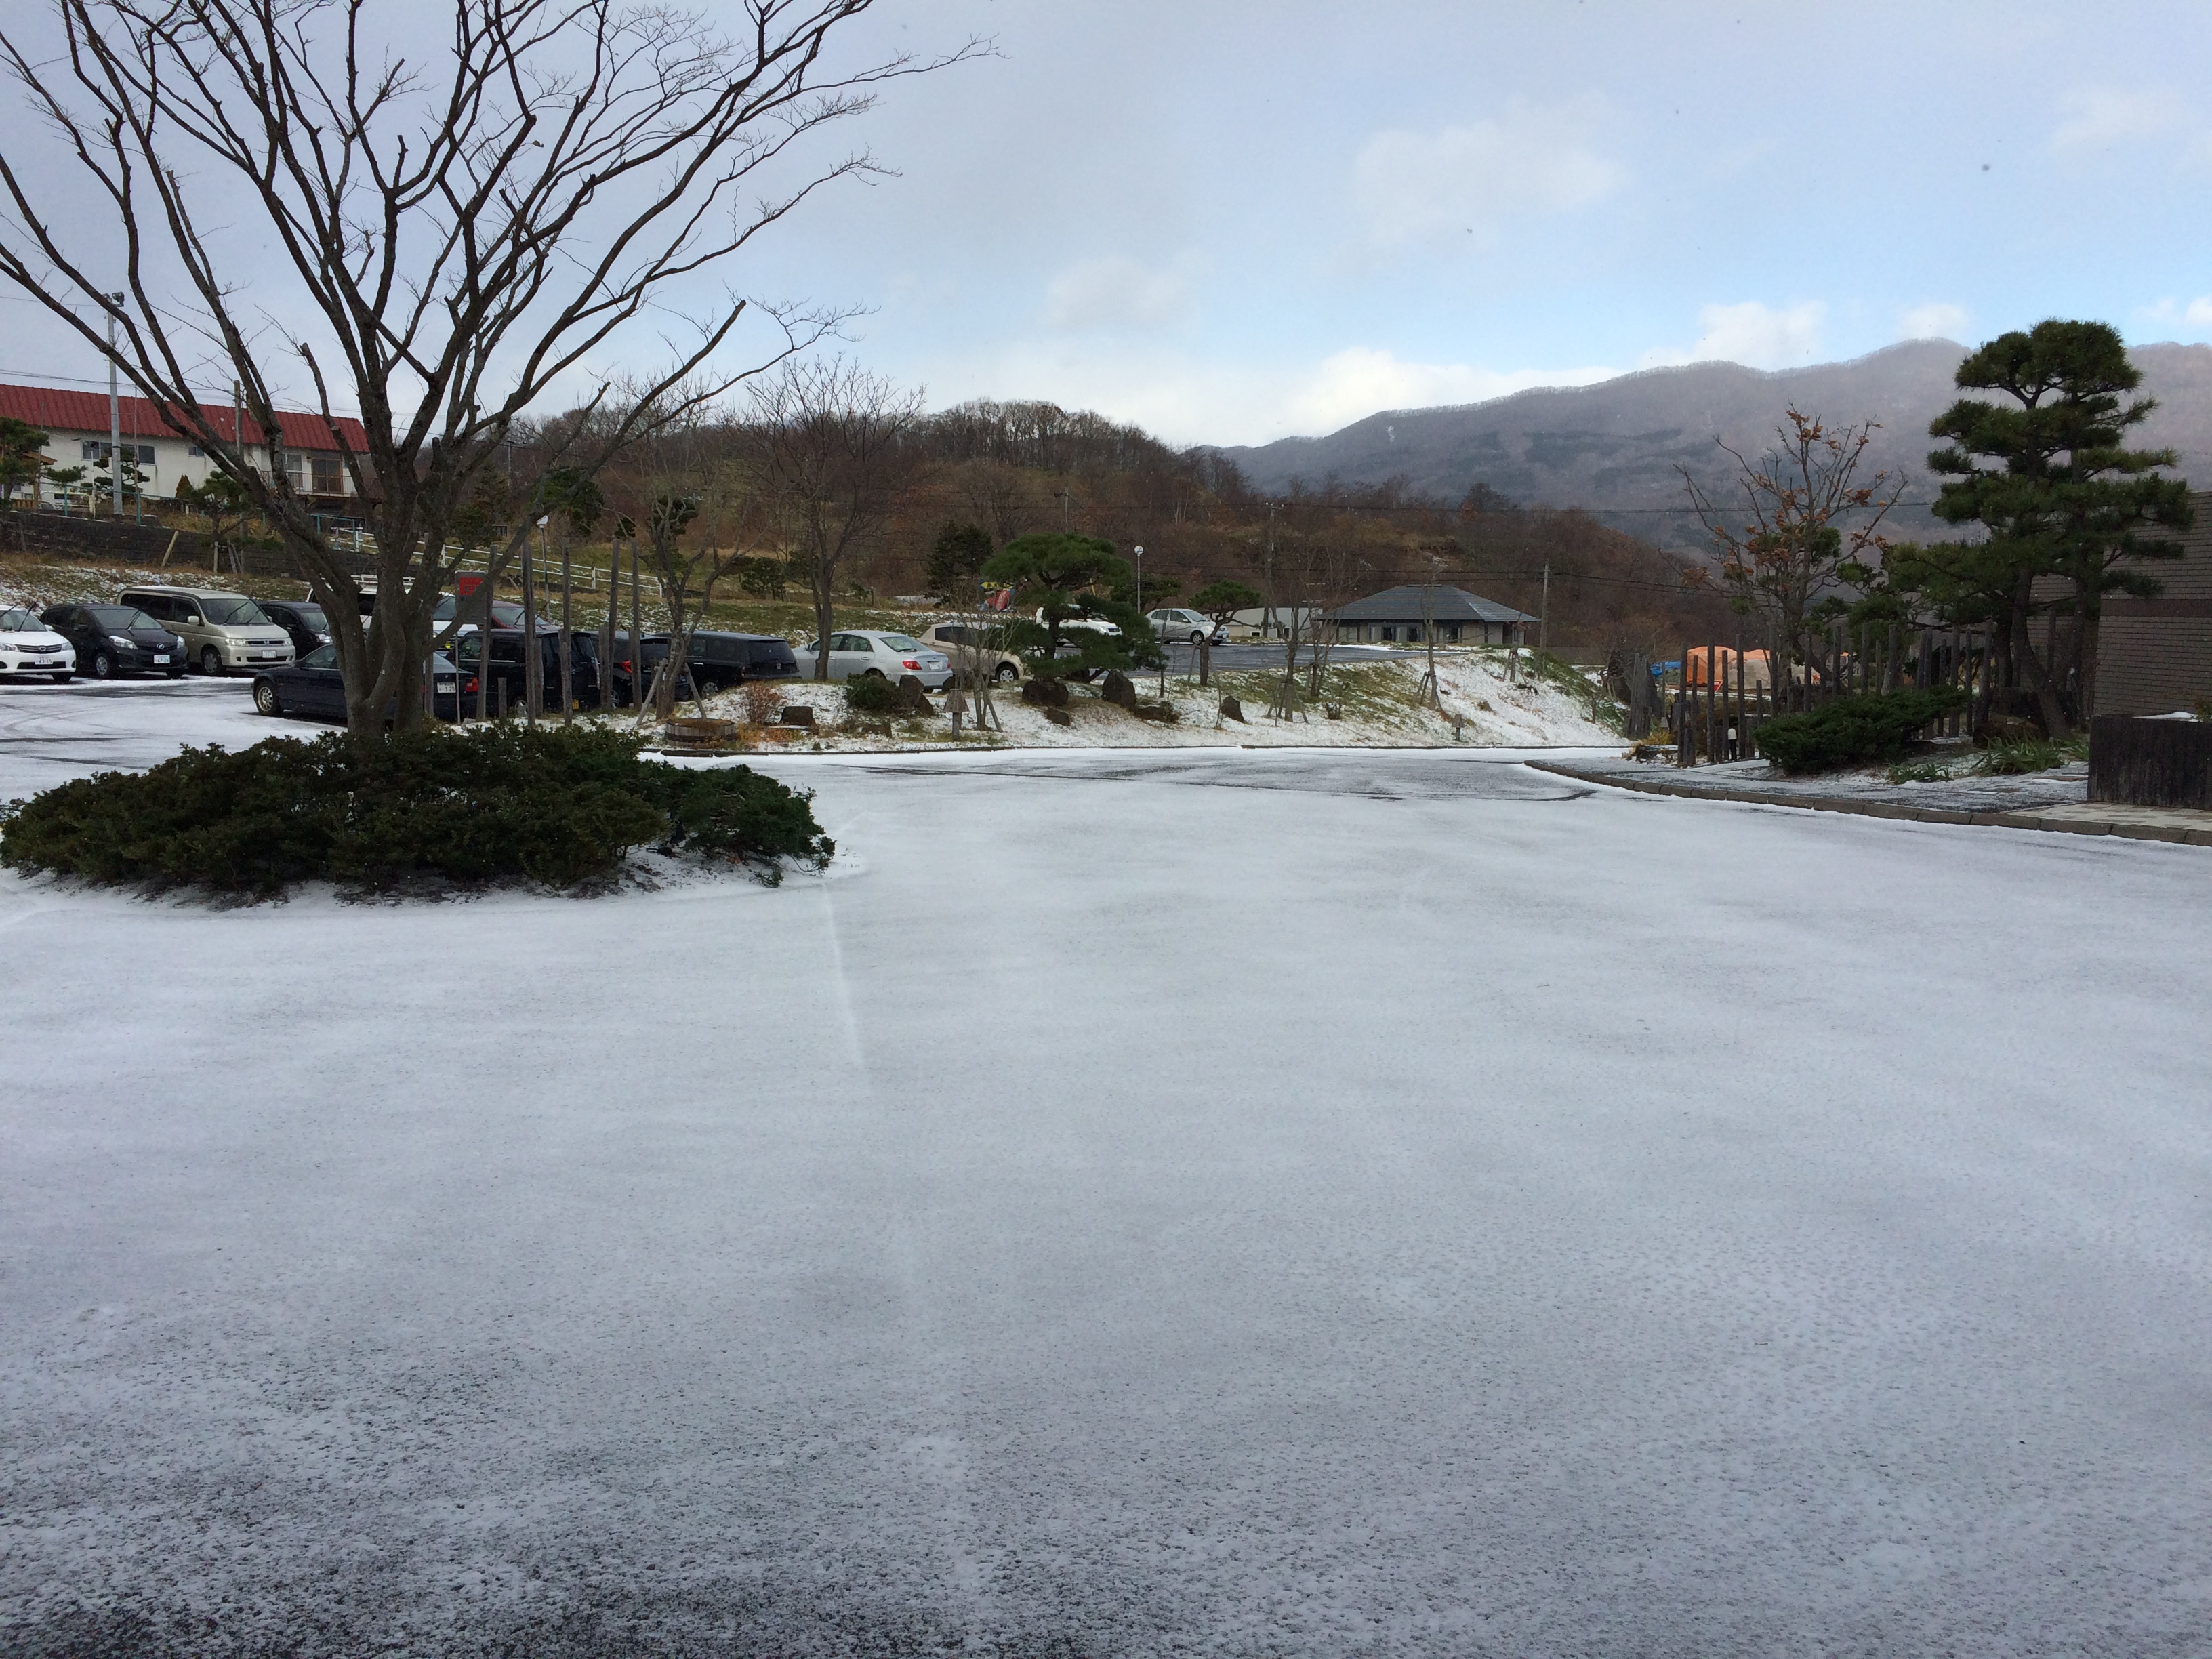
[0,726,834,894]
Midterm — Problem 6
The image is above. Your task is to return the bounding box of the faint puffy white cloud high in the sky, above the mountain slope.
[1351,98,1628,248]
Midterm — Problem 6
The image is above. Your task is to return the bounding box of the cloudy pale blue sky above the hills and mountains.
[13,0,2212,443]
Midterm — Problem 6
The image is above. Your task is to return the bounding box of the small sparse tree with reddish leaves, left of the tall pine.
[1675,405,1904,684]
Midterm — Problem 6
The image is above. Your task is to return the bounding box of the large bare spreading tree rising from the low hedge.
[0,0,980,730]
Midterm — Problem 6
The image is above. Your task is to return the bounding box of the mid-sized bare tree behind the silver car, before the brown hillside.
[752,359,922,679]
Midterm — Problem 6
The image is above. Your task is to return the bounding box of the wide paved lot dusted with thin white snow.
[13,688,2212,1657]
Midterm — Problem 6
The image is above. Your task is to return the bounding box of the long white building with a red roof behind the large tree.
[0,383,367,502]
